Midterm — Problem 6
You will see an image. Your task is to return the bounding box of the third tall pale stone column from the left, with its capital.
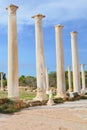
[55,25,66,97]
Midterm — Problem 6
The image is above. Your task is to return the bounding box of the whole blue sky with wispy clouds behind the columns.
[0,0,87,76]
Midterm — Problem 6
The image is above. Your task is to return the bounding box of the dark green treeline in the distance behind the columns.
[0,71,87,89]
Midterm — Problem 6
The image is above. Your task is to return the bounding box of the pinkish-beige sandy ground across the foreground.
[0,100,87,130]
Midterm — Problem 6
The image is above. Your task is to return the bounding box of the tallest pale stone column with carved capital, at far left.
[6,5,19,98]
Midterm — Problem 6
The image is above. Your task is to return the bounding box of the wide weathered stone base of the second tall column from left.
[33,88,46,101]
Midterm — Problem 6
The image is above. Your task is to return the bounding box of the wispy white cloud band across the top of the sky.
[0,0,87,25]
